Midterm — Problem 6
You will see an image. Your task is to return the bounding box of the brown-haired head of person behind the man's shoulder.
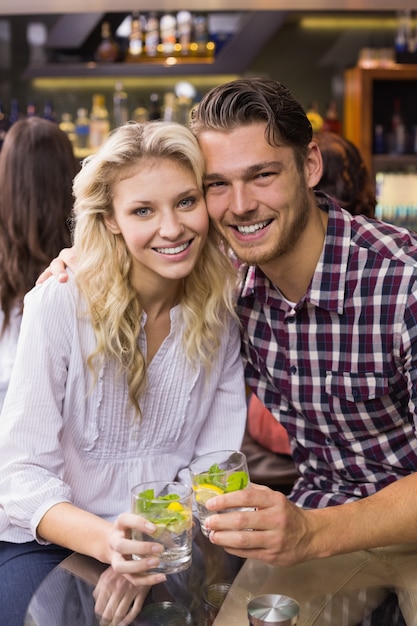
[313,131,376,218]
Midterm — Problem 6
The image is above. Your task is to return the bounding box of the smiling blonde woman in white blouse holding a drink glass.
[0,122,246,626]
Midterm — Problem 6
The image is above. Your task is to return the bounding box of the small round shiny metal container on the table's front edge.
[248,594,300,626]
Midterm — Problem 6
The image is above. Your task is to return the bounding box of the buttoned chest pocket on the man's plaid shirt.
[325,371,394,439]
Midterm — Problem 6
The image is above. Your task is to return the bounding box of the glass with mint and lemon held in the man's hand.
[188,450,252,537]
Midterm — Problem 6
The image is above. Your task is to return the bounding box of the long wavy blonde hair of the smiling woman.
[73,122,236,414]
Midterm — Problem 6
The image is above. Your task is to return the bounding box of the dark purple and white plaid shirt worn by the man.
[238,194,417,508]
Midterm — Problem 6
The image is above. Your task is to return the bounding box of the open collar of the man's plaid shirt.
[241,192,351,314]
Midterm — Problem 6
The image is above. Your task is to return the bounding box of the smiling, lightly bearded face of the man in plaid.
[198,123,321,266]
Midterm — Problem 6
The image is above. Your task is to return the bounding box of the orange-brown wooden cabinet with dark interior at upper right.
[344,64,417,174]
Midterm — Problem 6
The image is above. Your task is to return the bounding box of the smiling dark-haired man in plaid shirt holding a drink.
[191,78,417,626]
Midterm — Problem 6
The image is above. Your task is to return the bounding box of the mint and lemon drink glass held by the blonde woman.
[131,481,193,574]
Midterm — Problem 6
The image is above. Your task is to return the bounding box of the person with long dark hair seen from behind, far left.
[0,117,78,410]
